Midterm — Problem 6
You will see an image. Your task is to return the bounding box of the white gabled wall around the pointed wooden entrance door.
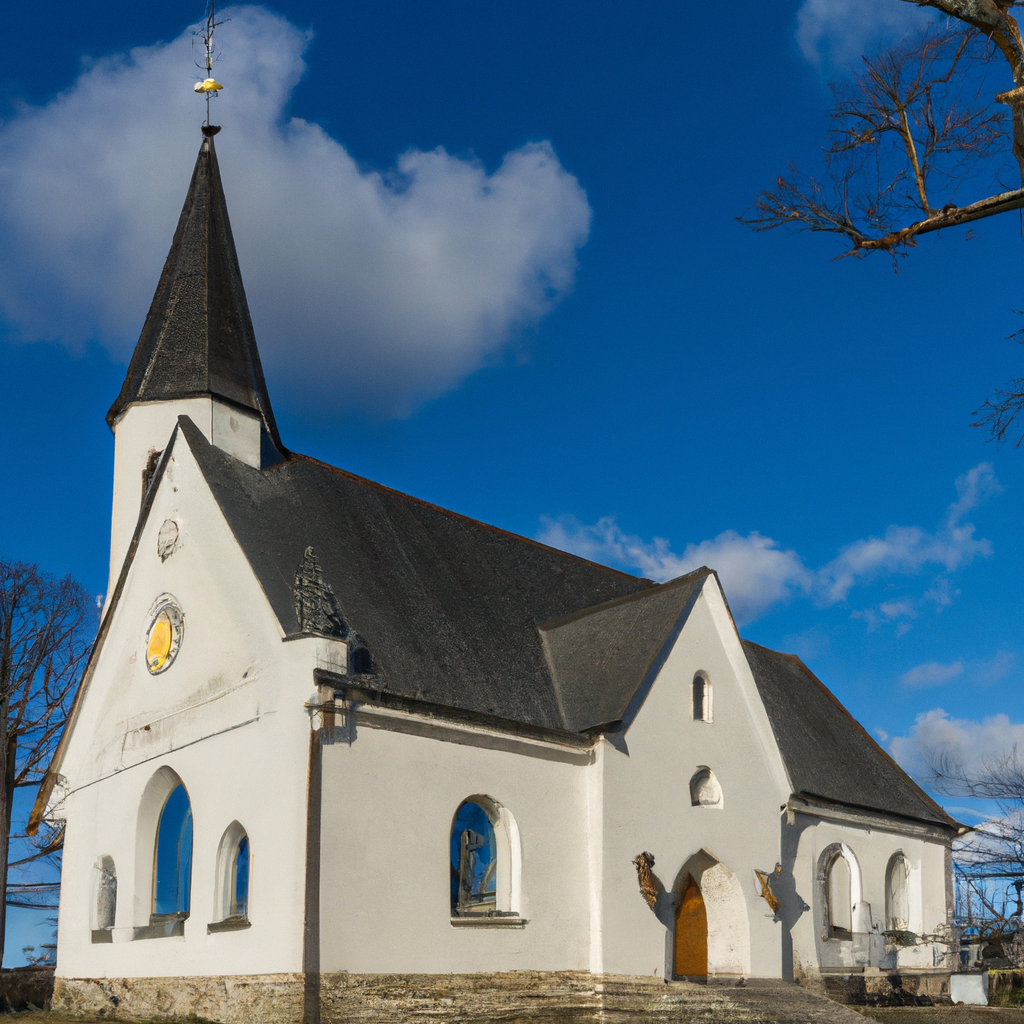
[595,579,790,977]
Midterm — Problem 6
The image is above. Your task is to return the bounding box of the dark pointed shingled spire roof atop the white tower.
[106,131,281,447]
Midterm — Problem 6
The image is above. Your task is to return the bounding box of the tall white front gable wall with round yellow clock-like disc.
[57,430,316,977]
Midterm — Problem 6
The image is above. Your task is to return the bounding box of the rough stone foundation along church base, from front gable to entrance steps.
[53,971,860,1024]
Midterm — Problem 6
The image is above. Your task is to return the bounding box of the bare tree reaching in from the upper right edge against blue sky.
[739,0,1024,447]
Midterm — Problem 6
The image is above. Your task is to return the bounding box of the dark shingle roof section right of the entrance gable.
[743,640,959,828]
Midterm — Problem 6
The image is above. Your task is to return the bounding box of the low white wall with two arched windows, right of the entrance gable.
[786,813,948,974]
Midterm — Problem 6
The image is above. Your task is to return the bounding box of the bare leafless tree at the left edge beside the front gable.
[0,561,96,959]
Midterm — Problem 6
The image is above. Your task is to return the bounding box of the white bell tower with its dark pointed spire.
[106,125,285,593]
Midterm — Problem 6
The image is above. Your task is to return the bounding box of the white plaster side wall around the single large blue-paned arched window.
[321,725,591,974]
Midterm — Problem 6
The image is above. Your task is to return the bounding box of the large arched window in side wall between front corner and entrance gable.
[449,796,520,919]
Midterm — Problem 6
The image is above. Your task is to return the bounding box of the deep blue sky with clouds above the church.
[0,0,1024,958]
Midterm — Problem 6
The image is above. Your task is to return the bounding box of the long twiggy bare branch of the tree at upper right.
[739,22,1011,256]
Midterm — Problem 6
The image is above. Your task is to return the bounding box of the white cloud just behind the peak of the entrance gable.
[538,516,810,622]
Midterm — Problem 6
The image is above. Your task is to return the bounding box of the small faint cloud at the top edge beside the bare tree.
[797,0,935,68]
